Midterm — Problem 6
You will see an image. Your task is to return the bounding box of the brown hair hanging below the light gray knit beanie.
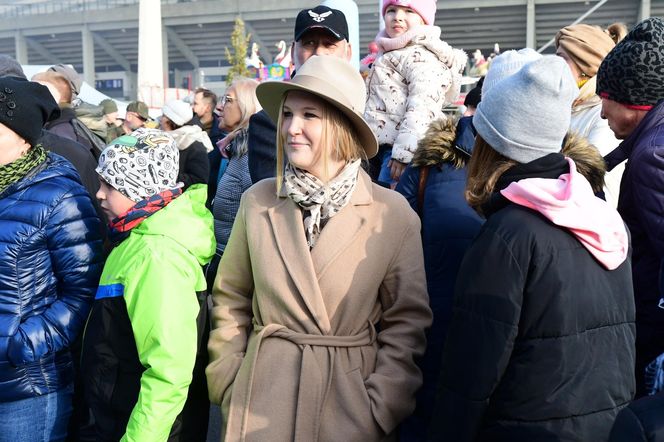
[465,135,518,214]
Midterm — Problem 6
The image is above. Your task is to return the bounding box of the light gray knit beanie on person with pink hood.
[473,55,579,163]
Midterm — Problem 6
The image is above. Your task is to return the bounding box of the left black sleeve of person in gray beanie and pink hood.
[431,228,527,442]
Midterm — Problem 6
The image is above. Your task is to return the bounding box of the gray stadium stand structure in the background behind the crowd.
[0,0,664,72]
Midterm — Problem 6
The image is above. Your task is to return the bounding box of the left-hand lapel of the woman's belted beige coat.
[268,189,330,334]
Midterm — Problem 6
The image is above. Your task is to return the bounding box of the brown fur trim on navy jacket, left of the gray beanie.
[412,118,470,169]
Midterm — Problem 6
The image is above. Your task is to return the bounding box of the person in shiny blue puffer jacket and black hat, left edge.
[0,77,103,442]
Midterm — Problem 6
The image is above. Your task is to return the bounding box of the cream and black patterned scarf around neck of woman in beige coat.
[284,160,360,250]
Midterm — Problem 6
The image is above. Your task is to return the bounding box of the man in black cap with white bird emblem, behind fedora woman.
[246,5,352,183]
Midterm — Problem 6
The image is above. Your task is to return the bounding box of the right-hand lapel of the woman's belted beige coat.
[312,171,373,277]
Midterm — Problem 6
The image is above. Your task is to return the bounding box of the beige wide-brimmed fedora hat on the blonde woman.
[256,55,378,158]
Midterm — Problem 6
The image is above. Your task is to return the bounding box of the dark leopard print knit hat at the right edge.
[597,17,664,106]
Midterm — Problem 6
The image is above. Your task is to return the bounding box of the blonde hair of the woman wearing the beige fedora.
[276,93,366,194]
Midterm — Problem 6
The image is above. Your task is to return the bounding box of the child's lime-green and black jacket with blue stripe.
[82,185,215,442]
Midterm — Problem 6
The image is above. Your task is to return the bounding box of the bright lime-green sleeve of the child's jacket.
[122,249,200,442]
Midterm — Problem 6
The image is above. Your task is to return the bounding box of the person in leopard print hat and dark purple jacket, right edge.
[597,17,664,397]
